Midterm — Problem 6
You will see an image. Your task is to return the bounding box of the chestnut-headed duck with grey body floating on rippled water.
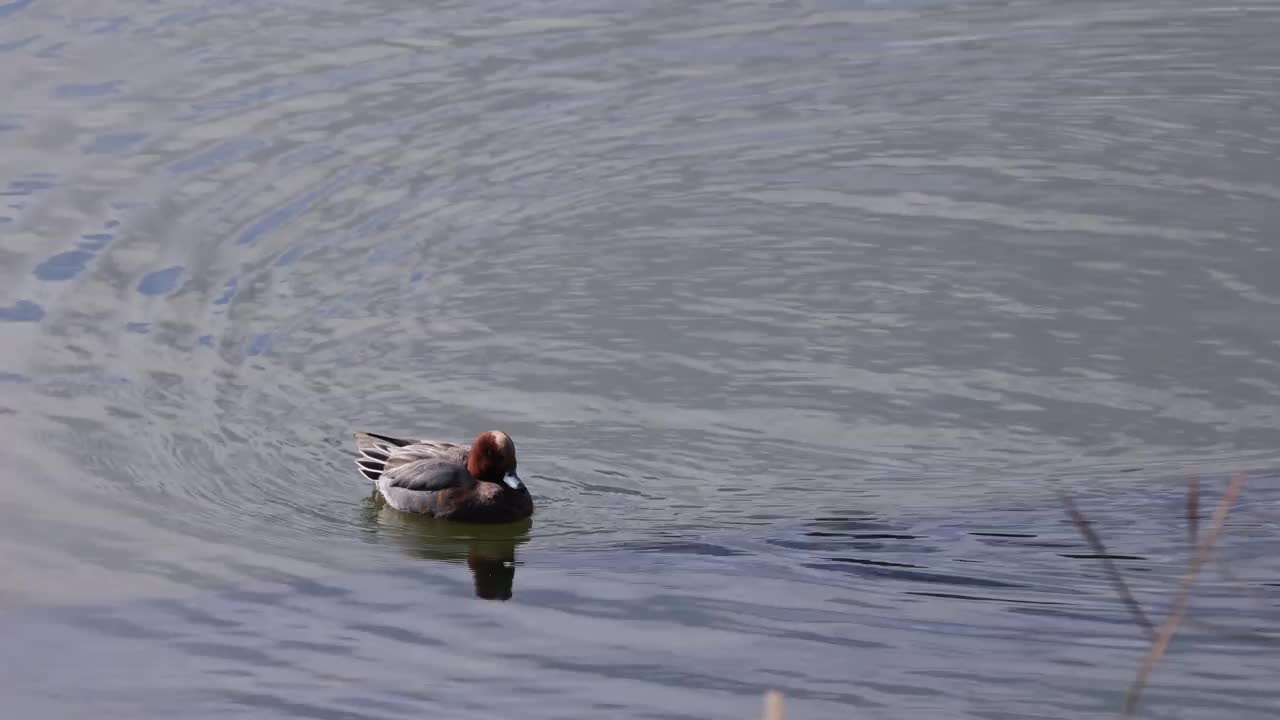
[355,430,534,523]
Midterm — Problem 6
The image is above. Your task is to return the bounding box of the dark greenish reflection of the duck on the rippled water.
[364,489,532,600]
